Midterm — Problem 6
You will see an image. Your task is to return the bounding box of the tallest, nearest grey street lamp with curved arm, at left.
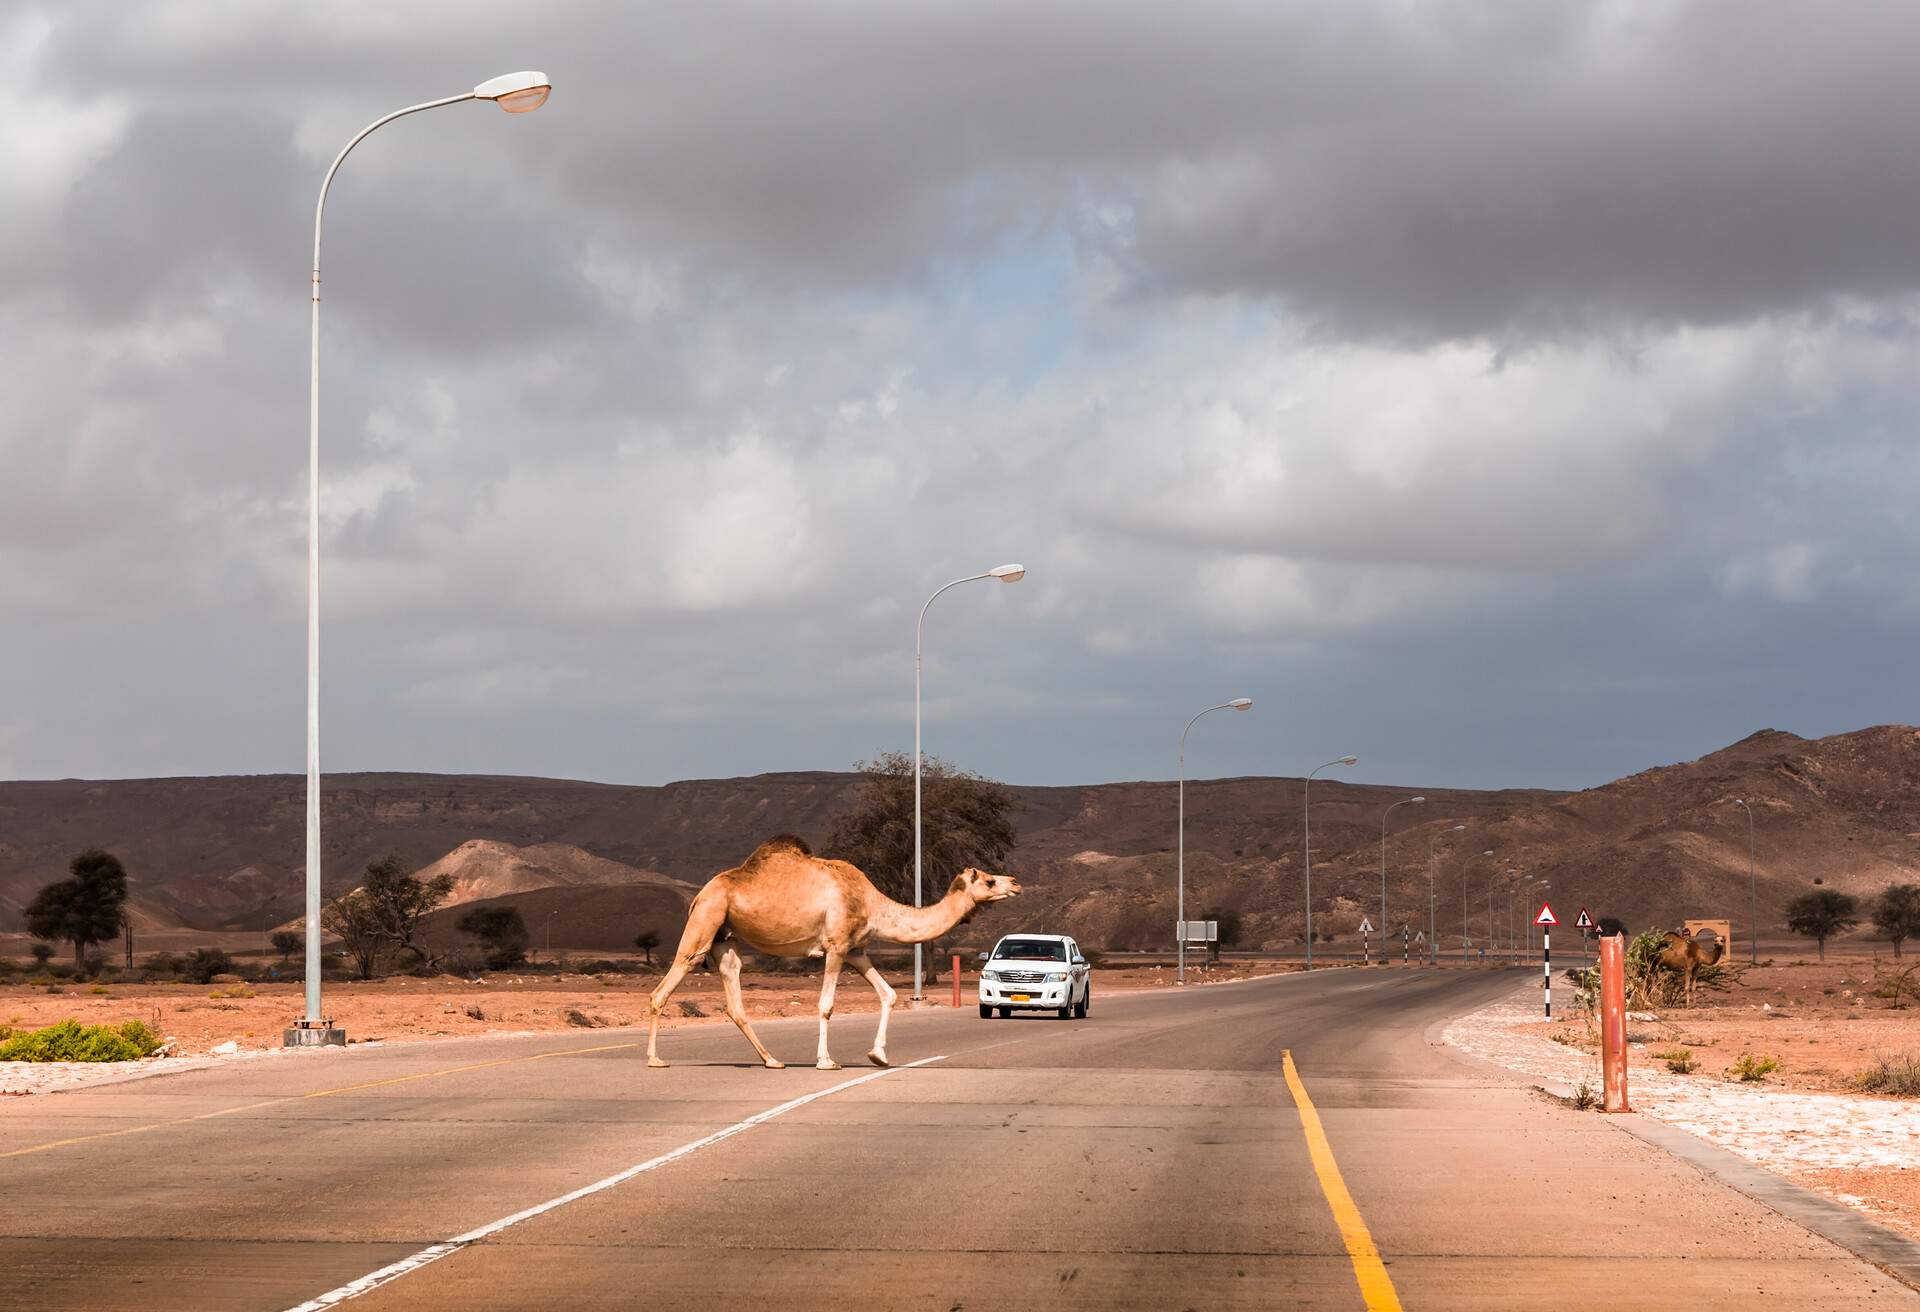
[284,71,553,1047]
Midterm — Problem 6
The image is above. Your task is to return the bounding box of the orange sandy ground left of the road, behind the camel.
[0,962,1294,1093]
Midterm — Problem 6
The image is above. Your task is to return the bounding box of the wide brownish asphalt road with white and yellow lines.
[0,968,1920,1312]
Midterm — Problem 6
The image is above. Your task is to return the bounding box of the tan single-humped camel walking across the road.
[647,834,1020,1070]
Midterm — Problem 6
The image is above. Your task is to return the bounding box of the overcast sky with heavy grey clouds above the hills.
[0,0,1920,788]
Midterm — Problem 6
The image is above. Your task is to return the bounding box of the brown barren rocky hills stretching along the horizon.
[0,726,1920,947]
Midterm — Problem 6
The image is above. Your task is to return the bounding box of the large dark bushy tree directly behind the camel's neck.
[824,751,1021,980]
